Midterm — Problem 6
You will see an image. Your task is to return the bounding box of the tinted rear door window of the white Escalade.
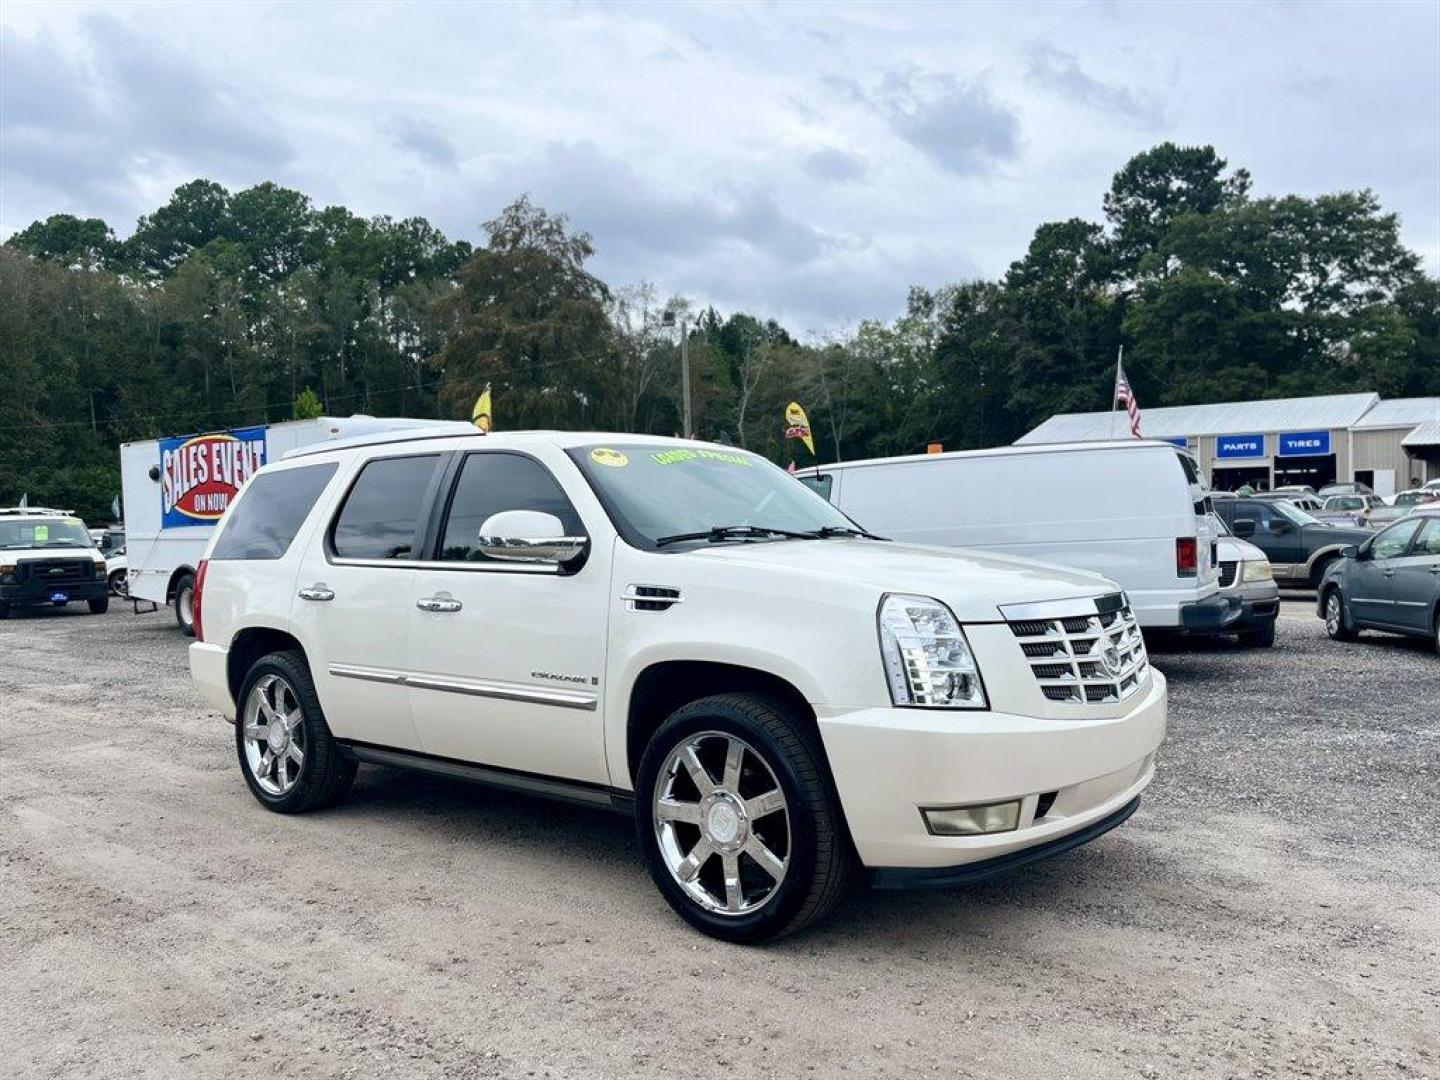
[330,454,439,559]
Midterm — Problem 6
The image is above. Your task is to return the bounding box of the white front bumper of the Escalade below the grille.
[819,670,1166,881]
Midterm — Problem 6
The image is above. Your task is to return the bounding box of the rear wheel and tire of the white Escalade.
[235,652,356,814]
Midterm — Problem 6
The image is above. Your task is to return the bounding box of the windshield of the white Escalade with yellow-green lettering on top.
[569,444,855,547]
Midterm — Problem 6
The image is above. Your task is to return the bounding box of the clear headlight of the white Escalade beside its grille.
[880,593,989,708]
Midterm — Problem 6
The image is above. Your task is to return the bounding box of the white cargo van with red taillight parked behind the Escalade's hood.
[796,439,1241,634]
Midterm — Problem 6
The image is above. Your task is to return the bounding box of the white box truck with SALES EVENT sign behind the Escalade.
[120,416,474,635]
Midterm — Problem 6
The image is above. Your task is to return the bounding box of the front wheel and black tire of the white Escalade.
[635,694,854,945]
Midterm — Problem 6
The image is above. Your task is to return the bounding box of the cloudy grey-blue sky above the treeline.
[0,0,1440,334]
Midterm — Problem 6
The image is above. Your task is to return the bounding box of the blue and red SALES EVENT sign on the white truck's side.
[160,428,265,528]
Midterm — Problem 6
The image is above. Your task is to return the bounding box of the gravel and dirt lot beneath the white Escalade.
[0,602,1440,1079]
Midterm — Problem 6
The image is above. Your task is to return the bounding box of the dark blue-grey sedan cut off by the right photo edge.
[1316,510,1440,651]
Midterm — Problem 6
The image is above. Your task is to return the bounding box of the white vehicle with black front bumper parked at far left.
[0,507,109,619]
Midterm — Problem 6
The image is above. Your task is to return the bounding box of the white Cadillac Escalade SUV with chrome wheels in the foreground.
[190,432,1165,942]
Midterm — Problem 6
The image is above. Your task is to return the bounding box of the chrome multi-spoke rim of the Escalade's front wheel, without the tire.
[651,732,791,916]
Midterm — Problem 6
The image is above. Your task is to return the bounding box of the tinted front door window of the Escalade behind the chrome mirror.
[439,454,585,562]
